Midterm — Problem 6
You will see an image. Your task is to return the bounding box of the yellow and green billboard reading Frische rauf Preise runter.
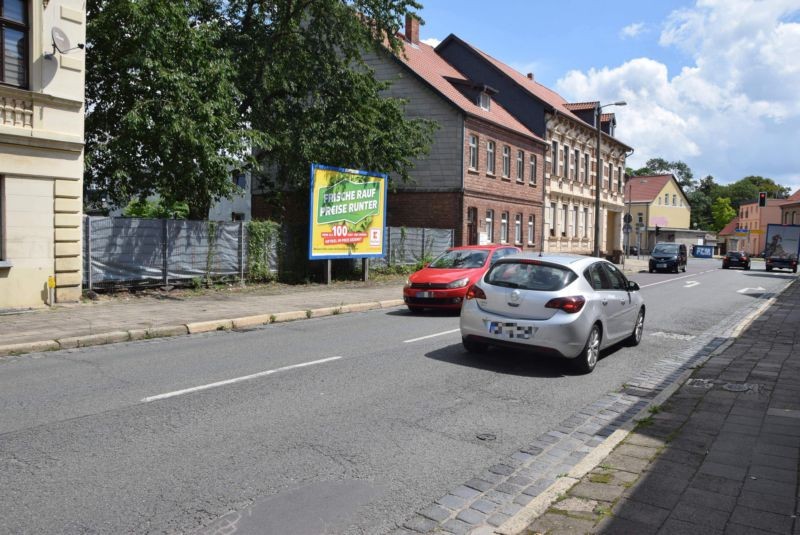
[308,164,388,260]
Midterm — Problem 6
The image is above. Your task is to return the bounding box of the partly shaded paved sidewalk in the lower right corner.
[524,283,800,535]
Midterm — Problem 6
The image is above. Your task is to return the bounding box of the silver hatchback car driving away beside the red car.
[461,253,645,373]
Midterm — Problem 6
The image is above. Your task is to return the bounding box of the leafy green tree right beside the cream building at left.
[85,0,255,219]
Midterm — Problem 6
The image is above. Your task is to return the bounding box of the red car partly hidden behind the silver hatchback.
[403,245,520,312]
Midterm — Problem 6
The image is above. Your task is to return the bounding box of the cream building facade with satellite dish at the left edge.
[0,0,86,309]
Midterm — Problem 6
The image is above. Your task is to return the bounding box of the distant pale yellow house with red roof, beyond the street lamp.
[625,174,692,251]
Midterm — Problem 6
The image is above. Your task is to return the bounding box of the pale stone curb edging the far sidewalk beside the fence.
[0,299,403,358]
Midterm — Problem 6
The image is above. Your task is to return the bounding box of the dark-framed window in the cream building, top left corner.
[0,0,29,87]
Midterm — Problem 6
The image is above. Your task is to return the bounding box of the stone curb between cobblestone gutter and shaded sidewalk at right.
[494,281,795,535]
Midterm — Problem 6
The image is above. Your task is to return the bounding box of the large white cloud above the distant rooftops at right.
[556,0,800,187]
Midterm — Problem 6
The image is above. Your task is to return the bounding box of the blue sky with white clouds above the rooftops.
[420,0,800,193]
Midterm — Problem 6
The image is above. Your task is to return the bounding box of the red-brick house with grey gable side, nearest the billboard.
[366,17,547,249]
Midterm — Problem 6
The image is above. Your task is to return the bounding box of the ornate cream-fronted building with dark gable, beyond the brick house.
[436,35,632,254]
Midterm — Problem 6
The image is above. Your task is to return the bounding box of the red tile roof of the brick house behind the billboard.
[395,34,544,143]
